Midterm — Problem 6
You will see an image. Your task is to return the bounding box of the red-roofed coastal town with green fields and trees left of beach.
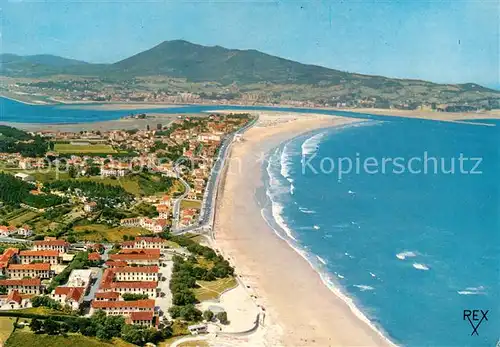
[0,113,259,345]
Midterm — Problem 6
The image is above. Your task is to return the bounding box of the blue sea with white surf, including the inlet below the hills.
[0,99,500,346]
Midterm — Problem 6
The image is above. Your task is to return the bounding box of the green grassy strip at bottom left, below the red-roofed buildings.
[5,328,134,347]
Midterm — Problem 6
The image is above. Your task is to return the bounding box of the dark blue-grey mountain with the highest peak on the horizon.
[112,40,351,84]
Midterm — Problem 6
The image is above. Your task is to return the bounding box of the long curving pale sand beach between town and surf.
[215,114,390,346]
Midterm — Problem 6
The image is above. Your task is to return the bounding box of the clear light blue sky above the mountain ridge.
[0,0,500,88]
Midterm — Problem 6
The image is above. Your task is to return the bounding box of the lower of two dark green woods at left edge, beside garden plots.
[0,173,66,208]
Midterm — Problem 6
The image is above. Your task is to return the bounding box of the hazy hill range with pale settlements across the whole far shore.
[0,40,500,108]
